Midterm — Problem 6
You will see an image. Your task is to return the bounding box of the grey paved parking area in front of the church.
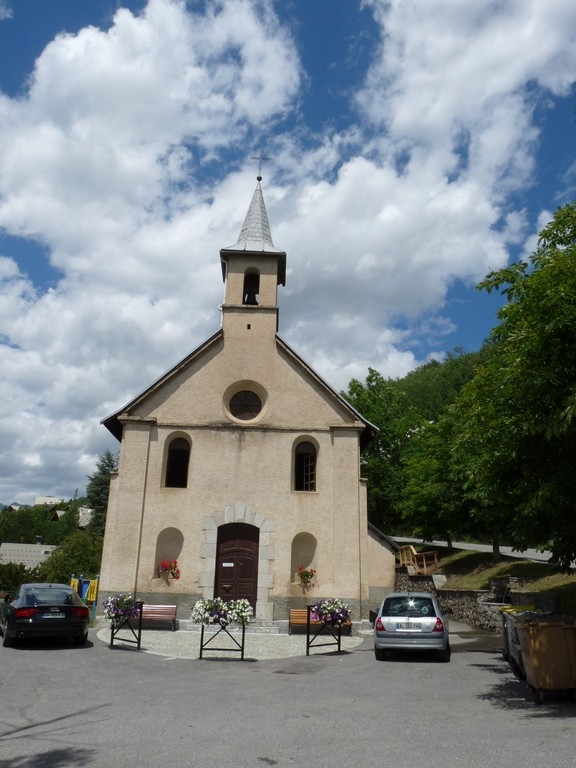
[0,623,576,768]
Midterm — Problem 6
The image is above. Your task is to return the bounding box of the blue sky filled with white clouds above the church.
[0,0,576,503]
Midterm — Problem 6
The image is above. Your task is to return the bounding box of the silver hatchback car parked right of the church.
[374,592,450,661]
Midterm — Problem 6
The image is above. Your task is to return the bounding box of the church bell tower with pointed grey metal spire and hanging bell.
[220,175,286,336]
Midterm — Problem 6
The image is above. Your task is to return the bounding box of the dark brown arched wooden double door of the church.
[214,523,260,612]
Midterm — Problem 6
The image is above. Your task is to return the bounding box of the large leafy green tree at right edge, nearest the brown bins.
[455,204,576,566]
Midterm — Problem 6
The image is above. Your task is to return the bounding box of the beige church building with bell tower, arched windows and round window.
[100,177,395,623]
